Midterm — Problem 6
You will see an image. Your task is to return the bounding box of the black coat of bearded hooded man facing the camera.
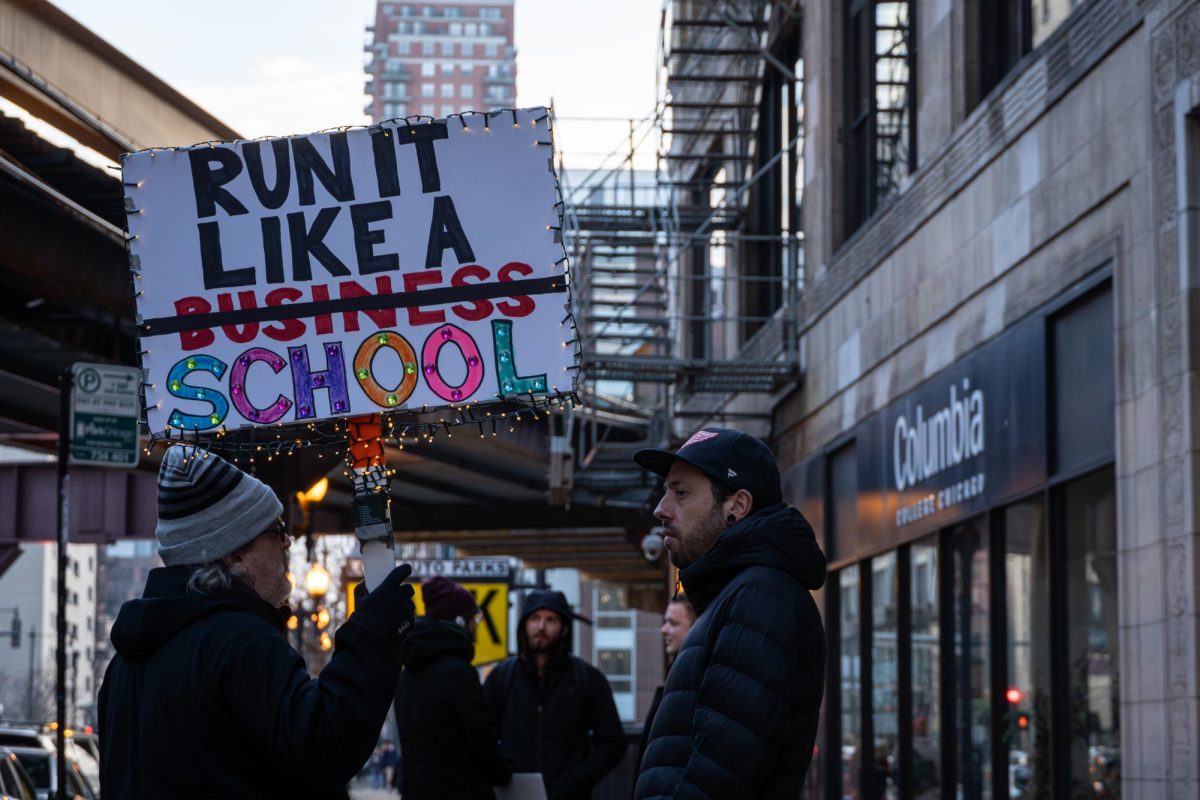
[484,652,625,800]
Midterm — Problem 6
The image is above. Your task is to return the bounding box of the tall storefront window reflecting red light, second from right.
[1000,499,1051,800]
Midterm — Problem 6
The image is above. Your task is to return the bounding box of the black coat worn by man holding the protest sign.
[98,566,401,800]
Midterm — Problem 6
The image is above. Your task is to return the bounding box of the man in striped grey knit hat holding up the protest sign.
[98,446,415,800]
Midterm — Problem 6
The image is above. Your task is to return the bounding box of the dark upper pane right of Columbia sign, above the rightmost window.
[1051,290,1115,471]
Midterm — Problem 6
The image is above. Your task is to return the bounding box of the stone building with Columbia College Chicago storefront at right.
[680,0,1200,798]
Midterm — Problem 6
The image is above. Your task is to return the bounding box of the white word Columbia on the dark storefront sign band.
[892,378,984,492]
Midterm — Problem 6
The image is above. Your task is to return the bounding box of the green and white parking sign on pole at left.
[71,362,142,468]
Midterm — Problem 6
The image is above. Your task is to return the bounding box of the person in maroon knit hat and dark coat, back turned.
[396,576,512,800]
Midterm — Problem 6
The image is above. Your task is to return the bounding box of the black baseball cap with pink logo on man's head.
[634,428,784,509]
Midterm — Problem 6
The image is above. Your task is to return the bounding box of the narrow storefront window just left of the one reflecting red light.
[952,522,991,800]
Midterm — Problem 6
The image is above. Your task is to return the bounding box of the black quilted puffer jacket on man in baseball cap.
[635,504,826,800]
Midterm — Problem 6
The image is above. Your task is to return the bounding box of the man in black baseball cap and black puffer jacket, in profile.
[634,428,826,800]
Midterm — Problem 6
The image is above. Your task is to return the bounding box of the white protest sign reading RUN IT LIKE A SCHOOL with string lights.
[122,108,575,435]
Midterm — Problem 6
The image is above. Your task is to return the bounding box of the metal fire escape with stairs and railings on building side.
[564,0,803,505]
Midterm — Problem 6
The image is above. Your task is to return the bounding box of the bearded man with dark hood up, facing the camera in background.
[484,590,625,800]
